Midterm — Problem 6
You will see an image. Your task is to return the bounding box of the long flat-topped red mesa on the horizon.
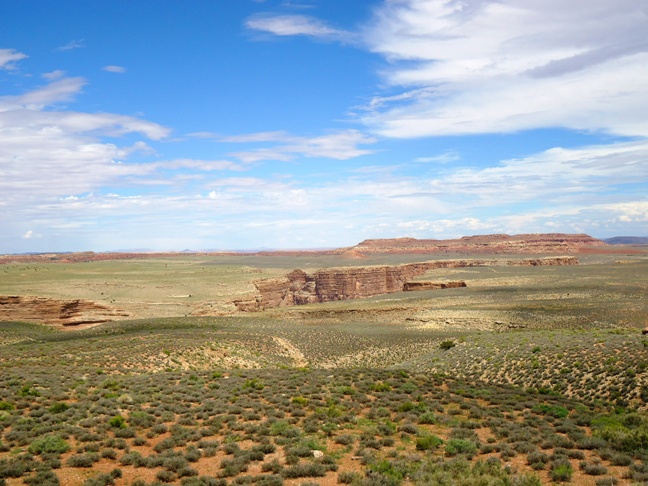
[337,233,608,255]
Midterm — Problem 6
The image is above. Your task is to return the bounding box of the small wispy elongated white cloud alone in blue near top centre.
[245,14,356,42]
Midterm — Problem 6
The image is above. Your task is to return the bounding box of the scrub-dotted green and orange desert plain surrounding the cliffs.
[0,249,648,486]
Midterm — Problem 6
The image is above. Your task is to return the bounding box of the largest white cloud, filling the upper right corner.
[363,0,648,137]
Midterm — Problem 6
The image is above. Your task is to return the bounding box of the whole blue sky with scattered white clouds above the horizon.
[0,0,648,253]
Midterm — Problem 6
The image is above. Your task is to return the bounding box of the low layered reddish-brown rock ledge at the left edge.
[0,295,125,327]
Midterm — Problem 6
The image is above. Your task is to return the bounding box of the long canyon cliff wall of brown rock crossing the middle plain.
[234,257,578,311]
